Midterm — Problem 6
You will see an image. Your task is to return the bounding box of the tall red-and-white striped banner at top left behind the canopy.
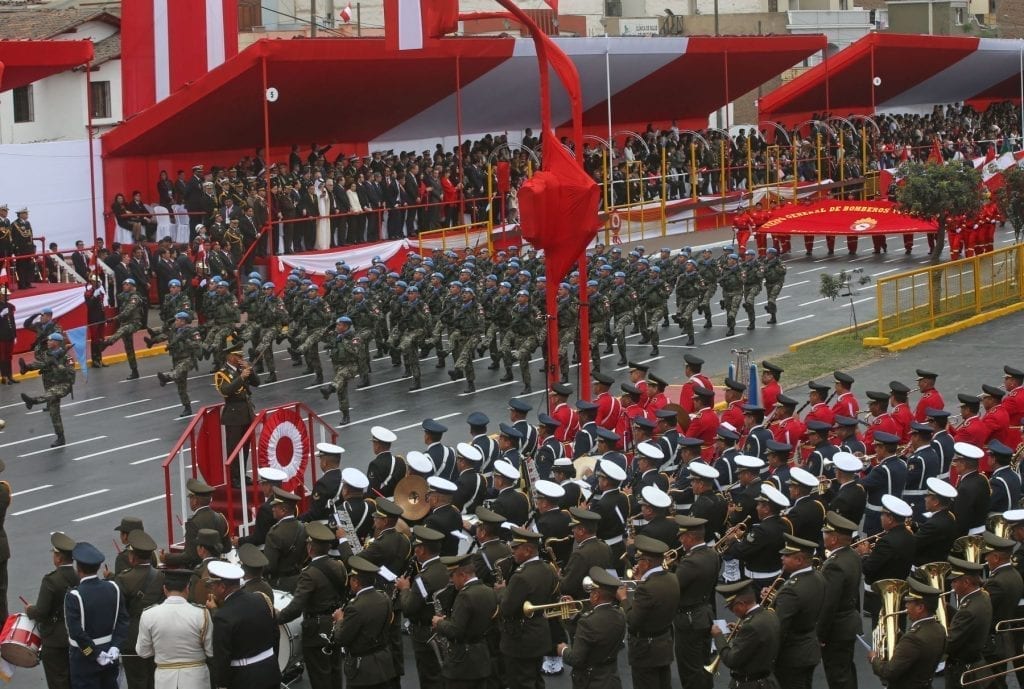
[121,0,239,119]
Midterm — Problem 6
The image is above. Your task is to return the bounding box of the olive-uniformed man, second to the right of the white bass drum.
[334,555,398,689]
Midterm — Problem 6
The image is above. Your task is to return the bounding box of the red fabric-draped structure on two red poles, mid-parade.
[498,0,600,399]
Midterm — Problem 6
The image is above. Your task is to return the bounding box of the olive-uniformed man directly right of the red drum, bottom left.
[25,531,78,689]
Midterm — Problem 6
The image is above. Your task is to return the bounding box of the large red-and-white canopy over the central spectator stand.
[103,36,824,157]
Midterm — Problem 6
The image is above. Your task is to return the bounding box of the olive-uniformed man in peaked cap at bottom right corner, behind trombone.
[982,531,1024,689]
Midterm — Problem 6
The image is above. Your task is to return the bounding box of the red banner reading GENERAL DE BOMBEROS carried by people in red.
[757,201,936,234]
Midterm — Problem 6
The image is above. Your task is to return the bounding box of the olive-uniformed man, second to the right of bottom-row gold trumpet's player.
[673,515,720,689]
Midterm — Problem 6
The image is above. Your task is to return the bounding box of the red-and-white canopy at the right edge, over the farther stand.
[759,34,1024,123]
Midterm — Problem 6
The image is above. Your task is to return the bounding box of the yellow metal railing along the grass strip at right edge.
[876,244,1024,338]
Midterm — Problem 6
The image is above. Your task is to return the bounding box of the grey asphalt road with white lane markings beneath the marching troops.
[8,229,1024,689]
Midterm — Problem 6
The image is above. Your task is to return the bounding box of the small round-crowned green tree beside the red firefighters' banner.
[896,161,982,263]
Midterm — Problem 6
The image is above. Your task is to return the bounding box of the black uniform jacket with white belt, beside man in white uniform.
[210,591,281,689]
